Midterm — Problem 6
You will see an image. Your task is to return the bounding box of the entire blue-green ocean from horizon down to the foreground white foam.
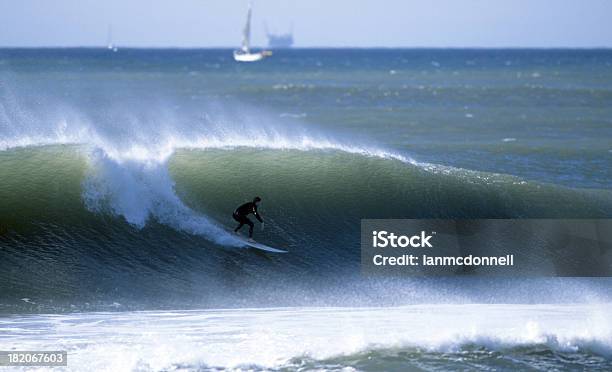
[0,48,612,371]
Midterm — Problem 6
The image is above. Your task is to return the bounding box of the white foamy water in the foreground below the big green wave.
[0,304,612,371]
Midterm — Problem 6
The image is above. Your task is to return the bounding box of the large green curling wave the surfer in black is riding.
[0,144,612,311]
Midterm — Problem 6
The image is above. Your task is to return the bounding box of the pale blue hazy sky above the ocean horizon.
[0,0,612,47]
